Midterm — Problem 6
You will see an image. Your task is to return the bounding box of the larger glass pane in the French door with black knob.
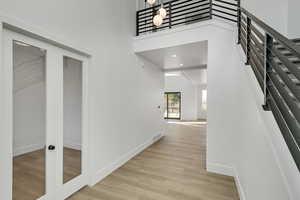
[12,41,46,200]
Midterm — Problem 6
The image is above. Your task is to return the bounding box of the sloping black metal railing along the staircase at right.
[238,8,300,170]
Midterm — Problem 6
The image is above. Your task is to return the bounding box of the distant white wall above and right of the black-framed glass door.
[165,75,200,120]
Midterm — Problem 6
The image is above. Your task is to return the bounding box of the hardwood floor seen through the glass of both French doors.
[13,148,81,200]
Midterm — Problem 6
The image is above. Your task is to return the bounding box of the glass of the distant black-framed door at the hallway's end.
[168,93,181,119]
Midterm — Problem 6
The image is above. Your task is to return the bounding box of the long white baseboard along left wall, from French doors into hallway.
[90,134,163,186]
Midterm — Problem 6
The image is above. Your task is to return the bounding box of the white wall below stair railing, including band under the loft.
[135,20,300,200]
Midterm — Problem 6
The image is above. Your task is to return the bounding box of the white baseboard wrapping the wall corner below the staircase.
[207,163,246,200]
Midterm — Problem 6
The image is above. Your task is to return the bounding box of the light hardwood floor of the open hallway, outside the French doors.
[69,122,239,200]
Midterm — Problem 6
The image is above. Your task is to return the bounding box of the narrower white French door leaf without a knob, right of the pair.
[59,49,88,199]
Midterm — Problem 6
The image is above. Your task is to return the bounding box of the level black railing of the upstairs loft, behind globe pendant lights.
[136,0,240,36]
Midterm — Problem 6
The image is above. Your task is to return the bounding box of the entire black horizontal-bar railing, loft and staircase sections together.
[137,0,300,170]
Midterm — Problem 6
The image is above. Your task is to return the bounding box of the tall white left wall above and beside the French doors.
[0,0,164,198]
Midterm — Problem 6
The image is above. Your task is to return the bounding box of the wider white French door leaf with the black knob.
[4,30,62,200]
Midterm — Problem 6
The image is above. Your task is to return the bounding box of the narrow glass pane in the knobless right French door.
[63,57,82,183]
